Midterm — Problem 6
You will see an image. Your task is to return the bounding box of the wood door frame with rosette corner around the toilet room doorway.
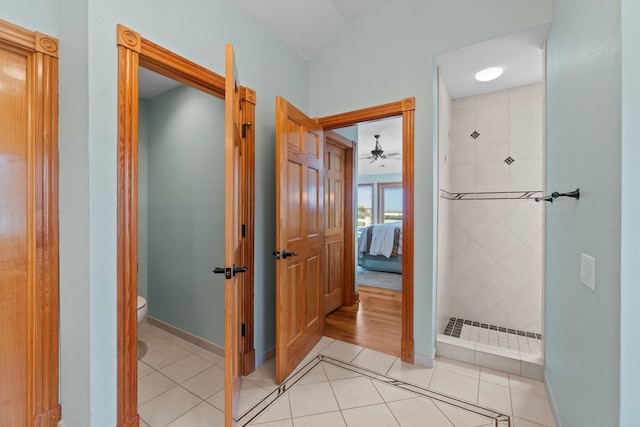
[116,24,256,427]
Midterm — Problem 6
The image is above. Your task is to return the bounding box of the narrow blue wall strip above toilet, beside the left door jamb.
[138,98,149,302]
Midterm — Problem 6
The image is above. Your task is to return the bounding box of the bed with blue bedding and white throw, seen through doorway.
[358,222,402,273]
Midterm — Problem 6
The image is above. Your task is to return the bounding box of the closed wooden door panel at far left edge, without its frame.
[0,38,29,426]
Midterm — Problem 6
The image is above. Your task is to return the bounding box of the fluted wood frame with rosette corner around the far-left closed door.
[0,19,61,427]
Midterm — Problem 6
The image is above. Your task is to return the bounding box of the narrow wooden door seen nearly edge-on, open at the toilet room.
[224,45,246,426]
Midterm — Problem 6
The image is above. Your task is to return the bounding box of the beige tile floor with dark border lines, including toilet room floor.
[138,324,554,427]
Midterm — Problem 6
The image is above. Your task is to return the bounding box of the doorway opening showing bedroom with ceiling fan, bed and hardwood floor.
[325,117,403,356]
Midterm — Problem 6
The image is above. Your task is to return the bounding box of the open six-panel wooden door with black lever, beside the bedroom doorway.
[276,97,324,383]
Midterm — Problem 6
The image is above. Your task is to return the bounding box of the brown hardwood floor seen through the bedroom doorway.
[324,285,402,356]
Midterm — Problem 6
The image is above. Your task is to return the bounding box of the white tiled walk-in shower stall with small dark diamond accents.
[436,78,545,377]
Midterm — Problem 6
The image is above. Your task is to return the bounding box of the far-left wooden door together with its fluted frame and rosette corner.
[0,20,60,427]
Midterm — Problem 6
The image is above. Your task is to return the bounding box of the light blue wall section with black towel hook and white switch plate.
[545,0,620,426]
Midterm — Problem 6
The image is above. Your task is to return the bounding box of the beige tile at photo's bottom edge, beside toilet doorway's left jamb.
[138,386,202,427]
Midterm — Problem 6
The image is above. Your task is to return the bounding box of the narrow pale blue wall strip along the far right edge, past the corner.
[620,0,640,427]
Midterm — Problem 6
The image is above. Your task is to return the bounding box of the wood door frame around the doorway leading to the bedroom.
[316,97,415,363]
